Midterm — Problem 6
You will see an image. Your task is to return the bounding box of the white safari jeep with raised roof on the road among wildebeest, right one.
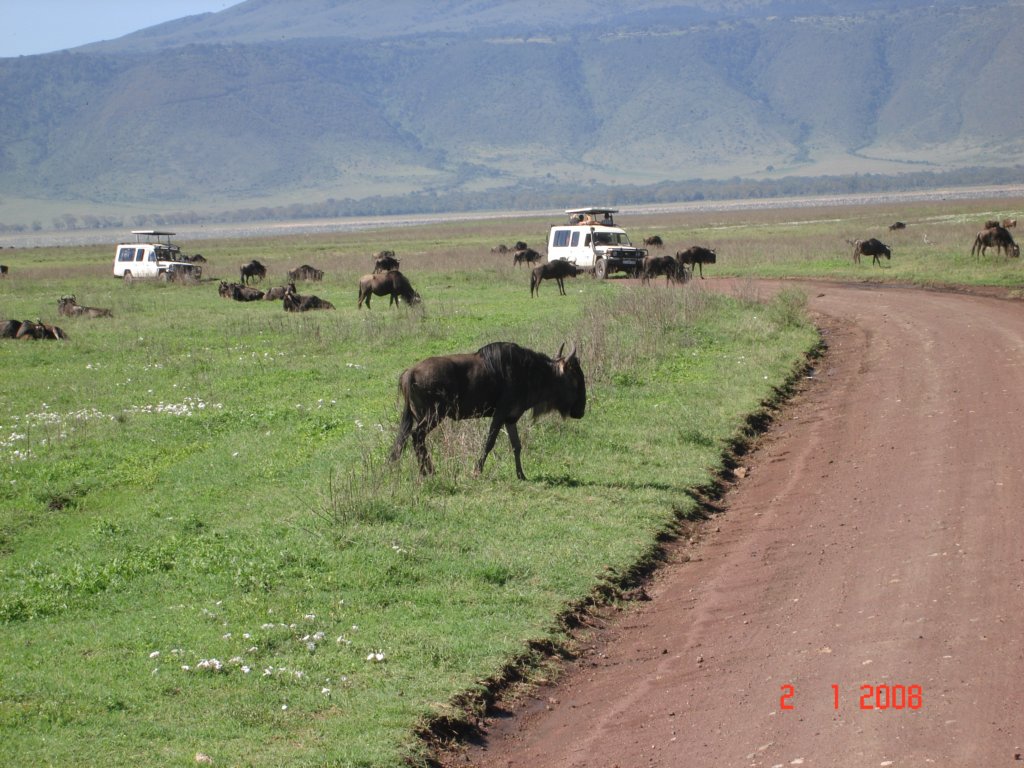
[548,208,647,280]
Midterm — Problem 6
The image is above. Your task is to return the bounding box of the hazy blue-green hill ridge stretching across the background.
[0,0,1024,222]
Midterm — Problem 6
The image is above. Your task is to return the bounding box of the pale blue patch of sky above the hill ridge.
[0,0,241,56]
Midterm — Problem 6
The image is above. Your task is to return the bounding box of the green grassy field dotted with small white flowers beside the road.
[0,196,1020,766]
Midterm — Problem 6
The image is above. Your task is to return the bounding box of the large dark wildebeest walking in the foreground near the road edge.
[391,341,587,480]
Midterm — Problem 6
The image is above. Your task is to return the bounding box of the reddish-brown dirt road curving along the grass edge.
[453,281,1024,768]
